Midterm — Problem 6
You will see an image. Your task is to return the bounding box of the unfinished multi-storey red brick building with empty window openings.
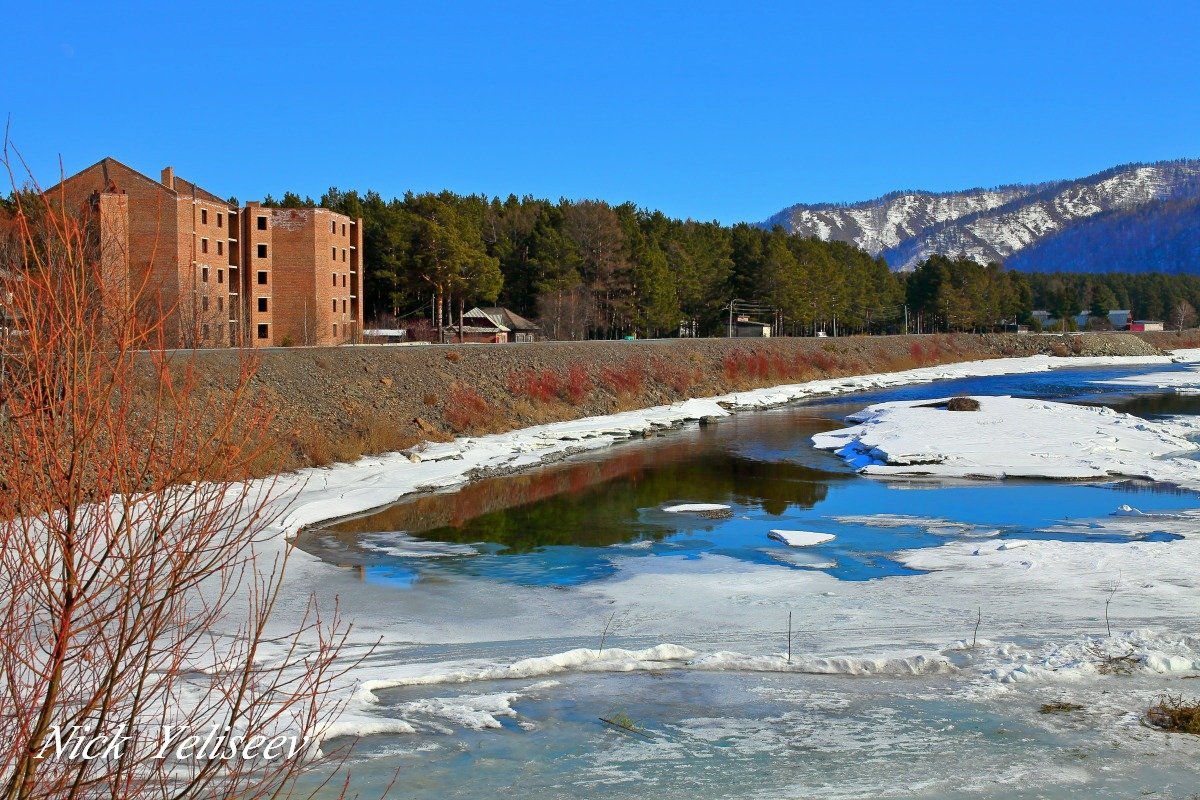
[48,158,362,347]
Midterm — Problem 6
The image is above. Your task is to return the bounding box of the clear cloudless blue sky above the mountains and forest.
[0,0,1200,222]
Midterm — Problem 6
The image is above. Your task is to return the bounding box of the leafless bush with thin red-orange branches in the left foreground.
[0,154,346,800]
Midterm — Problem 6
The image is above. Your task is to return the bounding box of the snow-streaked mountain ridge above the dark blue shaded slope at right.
[763,161,1200,270]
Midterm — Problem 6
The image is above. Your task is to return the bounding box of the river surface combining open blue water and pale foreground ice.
[290,366,1200,798]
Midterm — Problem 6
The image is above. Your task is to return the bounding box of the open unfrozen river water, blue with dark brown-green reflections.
[299,367,1200,589]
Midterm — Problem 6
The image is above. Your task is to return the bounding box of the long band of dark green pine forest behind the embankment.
[142,187,1200,339]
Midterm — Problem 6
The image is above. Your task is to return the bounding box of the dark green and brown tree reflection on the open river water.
[334,441,850,553]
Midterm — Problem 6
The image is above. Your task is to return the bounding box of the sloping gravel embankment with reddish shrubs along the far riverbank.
[184,333,1161,469]
